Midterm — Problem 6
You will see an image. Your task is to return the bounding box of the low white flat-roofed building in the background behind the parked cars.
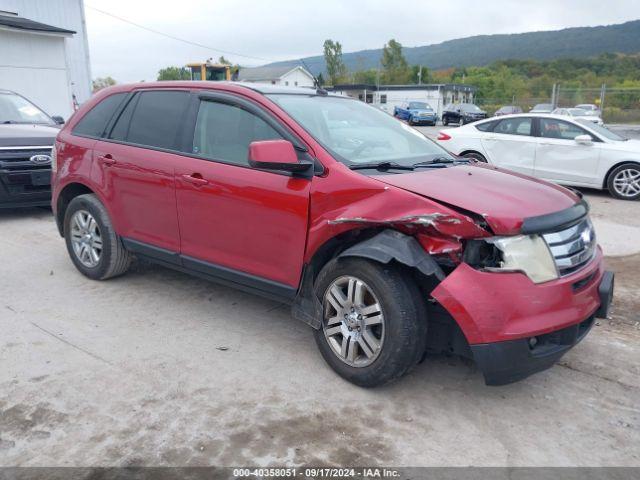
[331,83,476,116]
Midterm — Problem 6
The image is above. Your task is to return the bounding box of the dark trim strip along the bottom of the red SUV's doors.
[122,238,298,303]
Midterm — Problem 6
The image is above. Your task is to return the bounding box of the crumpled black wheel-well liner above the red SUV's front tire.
[338,229,445,280]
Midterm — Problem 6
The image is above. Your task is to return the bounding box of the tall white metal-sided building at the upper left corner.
[0,0,91,119]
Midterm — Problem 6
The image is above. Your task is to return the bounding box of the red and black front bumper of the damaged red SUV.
[432,251,614,385]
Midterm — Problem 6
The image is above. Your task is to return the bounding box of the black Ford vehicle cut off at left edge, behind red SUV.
[0,90,63,208]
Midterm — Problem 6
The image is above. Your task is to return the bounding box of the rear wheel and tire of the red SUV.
[64,194,132,280]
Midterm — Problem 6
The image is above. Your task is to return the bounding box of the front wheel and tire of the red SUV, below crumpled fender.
[314,258,427,387]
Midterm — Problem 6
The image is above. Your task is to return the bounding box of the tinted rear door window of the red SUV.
[109,91,189,150]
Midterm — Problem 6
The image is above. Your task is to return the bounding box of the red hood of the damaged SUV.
[374,165,580,235]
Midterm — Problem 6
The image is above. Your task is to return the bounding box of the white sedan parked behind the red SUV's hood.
[437,113,640,200]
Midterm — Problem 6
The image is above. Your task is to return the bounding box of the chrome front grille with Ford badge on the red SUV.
[543,218,596,276]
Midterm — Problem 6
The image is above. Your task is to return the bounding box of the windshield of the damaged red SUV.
[269,94,453,166]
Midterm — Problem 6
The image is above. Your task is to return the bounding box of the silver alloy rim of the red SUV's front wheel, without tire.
[322,276,385,367]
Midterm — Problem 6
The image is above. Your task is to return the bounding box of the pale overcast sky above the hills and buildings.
[85,0,640,83]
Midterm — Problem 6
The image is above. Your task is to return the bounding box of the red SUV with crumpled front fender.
[52,82,613,386]
